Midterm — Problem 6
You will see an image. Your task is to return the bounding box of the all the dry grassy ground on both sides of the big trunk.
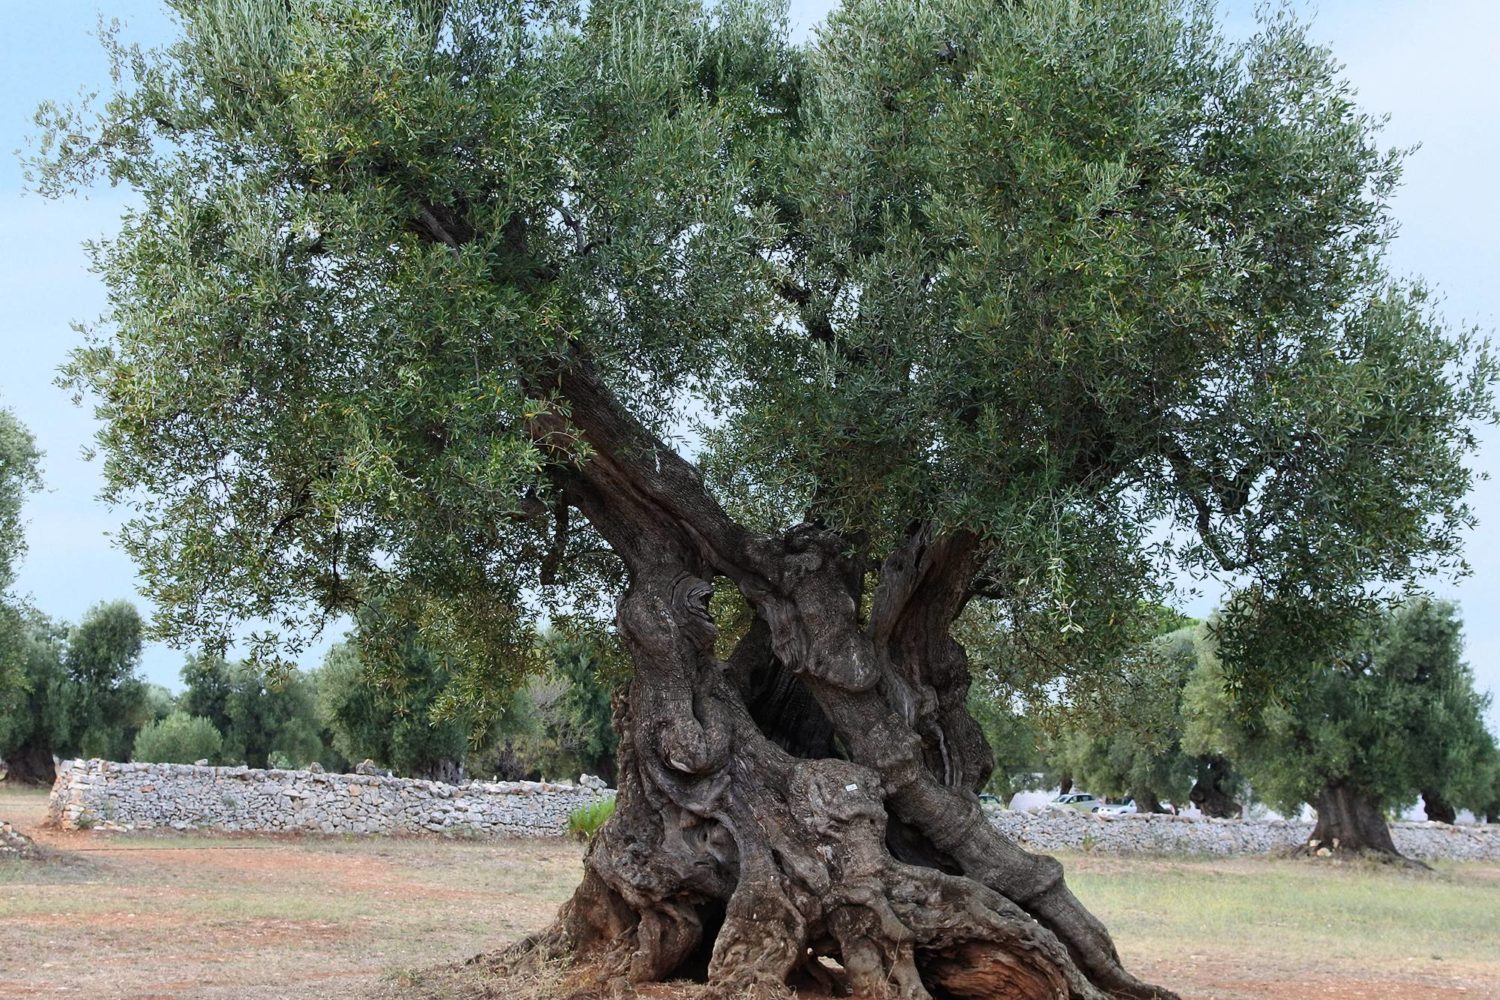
[0,786,1500,1000]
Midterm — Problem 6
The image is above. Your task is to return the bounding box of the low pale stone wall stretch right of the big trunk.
[990,808,1500,861]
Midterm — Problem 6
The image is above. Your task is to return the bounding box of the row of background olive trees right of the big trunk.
[971,598,1500,855]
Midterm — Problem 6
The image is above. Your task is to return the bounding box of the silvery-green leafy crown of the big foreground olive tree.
[32,0,1493,728]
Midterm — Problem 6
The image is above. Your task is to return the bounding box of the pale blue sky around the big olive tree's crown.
[0,0,1500,726]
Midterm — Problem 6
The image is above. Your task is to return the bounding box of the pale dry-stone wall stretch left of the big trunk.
[48,760,615,837]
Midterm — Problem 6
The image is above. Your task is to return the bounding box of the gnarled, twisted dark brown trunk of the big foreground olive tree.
[512,363,1173,1000]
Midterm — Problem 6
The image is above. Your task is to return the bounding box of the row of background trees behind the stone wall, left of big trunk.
[0,601,615,783]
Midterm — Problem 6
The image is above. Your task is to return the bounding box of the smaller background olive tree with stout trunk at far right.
[1184,598,1497,858]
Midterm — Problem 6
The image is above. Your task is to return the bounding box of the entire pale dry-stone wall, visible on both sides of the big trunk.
[50,760,1500,861]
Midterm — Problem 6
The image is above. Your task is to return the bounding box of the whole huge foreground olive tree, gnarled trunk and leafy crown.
[35,0,1490,997]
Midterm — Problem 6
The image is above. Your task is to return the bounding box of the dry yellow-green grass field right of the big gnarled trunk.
[1062,855,1500,1000]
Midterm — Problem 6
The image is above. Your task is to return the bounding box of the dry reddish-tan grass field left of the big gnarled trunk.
[0,790,581,999]
